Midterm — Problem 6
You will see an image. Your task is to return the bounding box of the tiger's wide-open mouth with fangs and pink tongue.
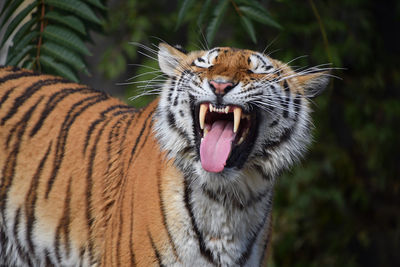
[194,102,257,172]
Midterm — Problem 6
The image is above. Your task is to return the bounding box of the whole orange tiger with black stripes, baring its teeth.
[0,43,330,266]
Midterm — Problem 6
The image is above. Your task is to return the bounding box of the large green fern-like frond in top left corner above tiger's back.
[0,0,106,81]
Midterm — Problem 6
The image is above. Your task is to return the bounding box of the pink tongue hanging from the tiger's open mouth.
[200,121,236,172]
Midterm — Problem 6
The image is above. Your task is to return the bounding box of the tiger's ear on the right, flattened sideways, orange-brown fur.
[296,71,330,97]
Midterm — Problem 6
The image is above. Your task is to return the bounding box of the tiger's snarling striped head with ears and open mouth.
[155,43,329,182]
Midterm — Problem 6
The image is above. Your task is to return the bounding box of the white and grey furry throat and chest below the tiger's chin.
[179,168,273,266]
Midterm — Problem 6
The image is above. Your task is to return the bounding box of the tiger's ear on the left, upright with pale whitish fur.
[158,43,186,76]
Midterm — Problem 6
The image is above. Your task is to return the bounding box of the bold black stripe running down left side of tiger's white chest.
[183,176,215,264]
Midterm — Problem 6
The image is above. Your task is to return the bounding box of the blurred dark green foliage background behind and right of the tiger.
[100,0,400,266]
